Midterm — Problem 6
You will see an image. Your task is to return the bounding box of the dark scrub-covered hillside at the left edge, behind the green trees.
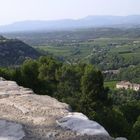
[0,36,40,66]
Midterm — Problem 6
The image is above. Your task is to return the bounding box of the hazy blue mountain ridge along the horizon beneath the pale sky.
[0,15,140,32]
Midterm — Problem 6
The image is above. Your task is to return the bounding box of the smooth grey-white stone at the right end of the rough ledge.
[58,112,109,136]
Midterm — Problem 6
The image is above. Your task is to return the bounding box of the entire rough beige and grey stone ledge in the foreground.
[0,78,112,140]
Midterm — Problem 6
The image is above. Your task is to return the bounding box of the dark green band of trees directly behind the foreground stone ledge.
[0,57,140,140]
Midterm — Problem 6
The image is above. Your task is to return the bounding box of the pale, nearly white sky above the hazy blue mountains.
[0,0,140,25]
